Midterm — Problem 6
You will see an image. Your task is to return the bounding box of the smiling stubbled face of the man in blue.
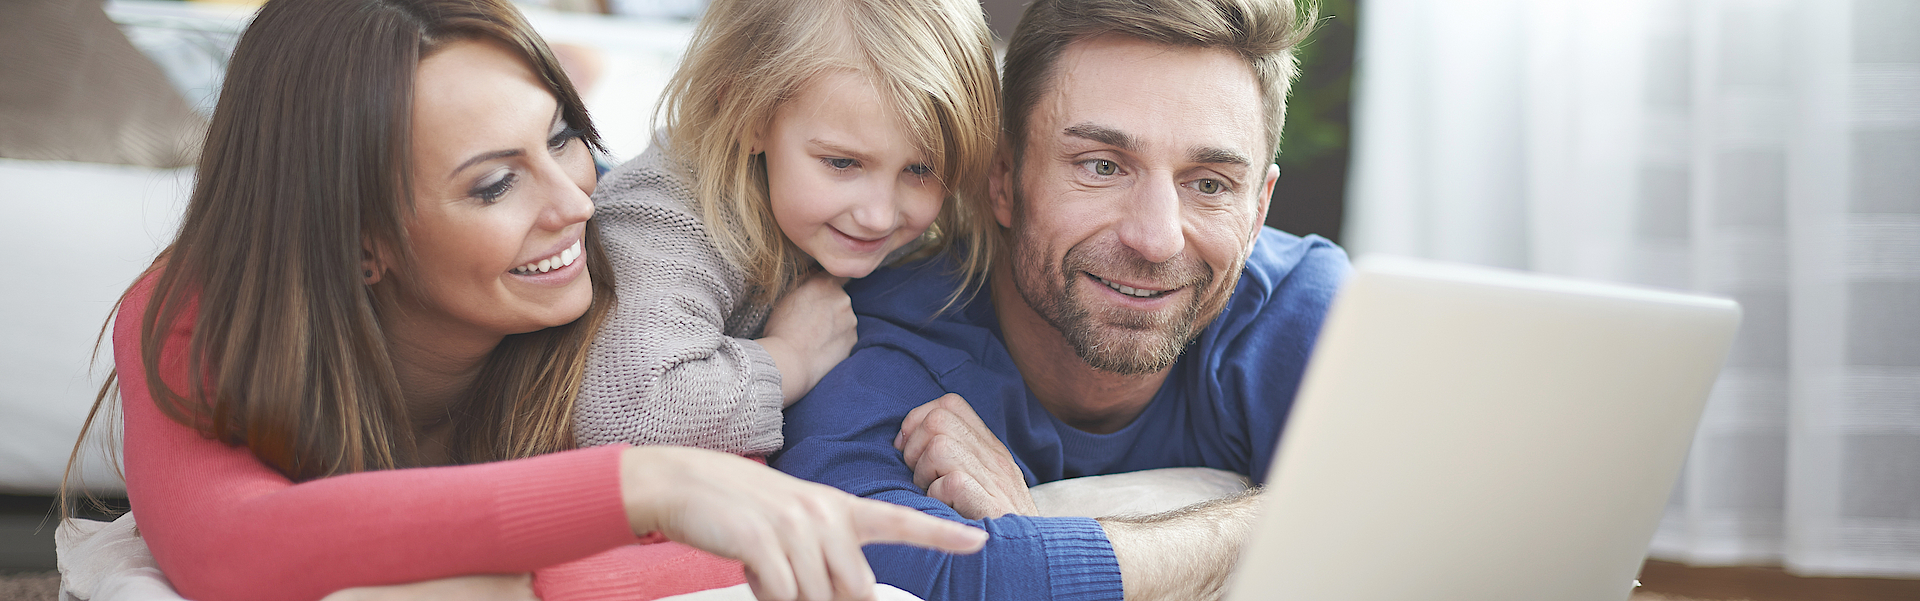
[993,36,1279,374]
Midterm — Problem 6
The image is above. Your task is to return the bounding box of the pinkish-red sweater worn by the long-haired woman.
[113,275,745,601]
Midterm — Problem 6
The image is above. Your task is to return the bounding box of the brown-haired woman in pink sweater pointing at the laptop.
[65,0,985,599]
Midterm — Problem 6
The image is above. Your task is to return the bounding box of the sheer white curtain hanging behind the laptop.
[1344,0,1920,578]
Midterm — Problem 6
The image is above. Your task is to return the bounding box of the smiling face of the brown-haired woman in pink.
[394,40,595,336]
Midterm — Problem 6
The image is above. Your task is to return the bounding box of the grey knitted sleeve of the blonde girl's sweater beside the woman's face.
[574,144,781,455]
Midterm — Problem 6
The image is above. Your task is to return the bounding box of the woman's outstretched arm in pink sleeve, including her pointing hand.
[113,280,983,601]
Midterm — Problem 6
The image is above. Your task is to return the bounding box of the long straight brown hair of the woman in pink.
[61,0,612,507]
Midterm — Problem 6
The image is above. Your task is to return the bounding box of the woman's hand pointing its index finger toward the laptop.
[620,447,987,601]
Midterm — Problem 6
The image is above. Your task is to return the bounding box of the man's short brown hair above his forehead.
[1000,0,1317,165]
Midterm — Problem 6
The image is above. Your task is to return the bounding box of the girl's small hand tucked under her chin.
[758,273,858,407]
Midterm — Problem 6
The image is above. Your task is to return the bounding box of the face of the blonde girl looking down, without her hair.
[753,71,945,278]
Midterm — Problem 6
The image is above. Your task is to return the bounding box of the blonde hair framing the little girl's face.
[659,0,1000,303]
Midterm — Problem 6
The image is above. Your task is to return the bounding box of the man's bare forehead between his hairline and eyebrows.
[1027,35,1265,165]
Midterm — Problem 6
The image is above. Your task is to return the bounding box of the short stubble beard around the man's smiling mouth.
[1012,185,1225,376]
